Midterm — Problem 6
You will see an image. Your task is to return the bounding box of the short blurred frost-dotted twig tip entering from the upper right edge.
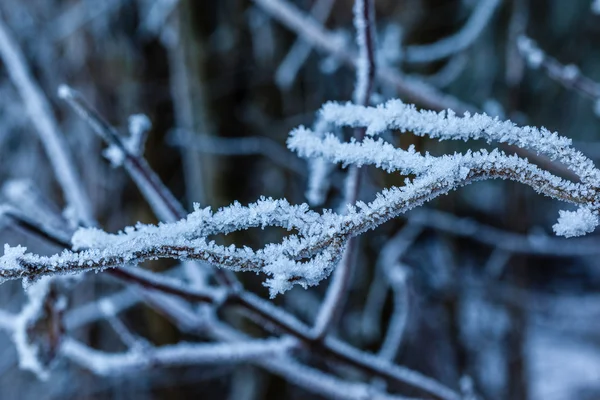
[517,35,600,114]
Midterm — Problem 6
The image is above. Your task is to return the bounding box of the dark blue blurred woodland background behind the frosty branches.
[0,0,600,400]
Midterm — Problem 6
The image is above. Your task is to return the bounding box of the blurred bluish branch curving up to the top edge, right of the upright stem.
[403,0,501,63]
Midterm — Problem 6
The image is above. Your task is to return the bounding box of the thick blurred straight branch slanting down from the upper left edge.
[0,17,94,226]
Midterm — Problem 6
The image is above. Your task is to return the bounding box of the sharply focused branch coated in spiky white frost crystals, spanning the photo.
[0,101,599,295]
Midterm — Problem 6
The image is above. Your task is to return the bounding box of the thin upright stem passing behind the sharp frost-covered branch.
[314,0,376,338]
